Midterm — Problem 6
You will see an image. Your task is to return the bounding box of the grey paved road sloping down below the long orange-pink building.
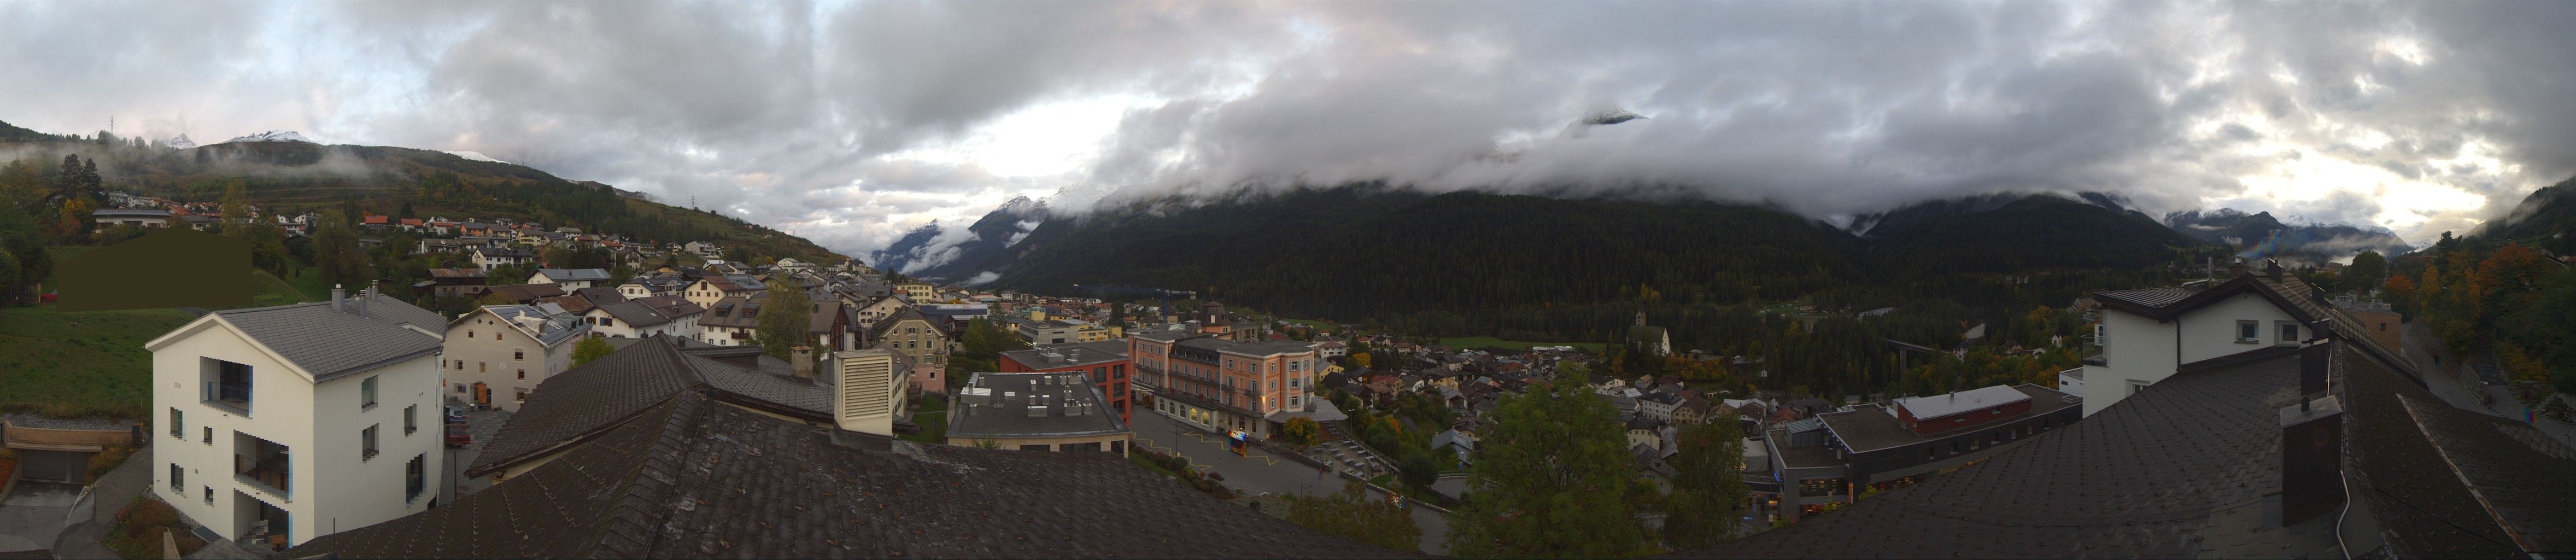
[1131,408,1448,555]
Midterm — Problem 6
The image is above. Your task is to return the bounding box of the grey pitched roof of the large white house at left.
[214,294,448,382]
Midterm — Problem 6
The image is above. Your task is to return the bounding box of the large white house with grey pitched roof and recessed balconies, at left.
[144,289,446,545]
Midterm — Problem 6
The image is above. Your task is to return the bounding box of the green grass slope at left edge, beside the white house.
[0,305,193,418]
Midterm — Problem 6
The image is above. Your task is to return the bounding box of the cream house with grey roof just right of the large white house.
[441,305,590,410]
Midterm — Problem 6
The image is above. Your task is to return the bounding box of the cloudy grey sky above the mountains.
[0,3,2576,253]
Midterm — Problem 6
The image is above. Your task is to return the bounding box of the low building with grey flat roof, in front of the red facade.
[948,372,1133,454]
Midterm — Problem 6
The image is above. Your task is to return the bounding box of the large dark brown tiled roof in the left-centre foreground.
[304,392,1417,557]
